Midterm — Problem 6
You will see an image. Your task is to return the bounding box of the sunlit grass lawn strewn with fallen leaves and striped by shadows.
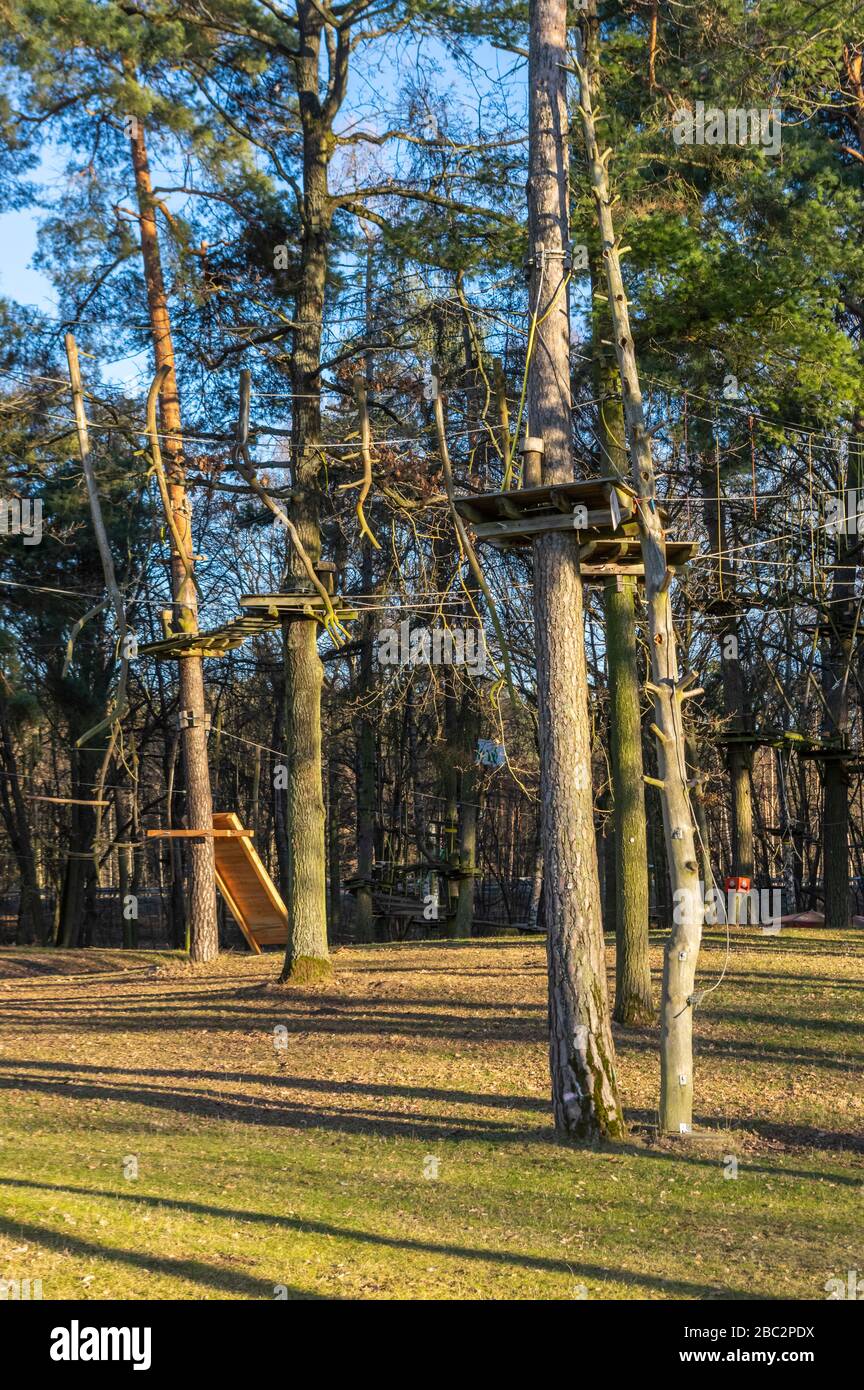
[0,929,864,1300]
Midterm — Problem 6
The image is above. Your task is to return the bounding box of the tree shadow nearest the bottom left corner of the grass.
[0,1212,324,1300]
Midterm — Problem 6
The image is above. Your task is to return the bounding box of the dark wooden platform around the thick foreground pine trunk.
[456,478,697,569]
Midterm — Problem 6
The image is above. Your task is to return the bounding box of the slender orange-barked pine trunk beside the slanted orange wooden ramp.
[131,121,219,960]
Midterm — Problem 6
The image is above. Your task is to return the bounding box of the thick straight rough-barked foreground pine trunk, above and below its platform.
[528,0,624,1140]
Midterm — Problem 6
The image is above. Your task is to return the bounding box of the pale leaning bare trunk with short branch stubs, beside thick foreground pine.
[576,16,704,1133]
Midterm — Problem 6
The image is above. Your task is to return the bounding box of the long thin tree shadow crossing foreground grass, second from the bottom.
[0,1177,761,1300]
